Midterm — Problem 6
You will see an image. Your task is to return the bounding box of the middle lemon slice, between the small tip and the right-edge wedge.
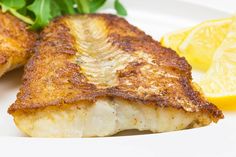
[179,18,232,71]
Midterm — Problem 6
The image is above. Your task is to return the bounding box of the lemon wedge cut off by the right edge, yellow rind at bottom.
[199,18,236,110]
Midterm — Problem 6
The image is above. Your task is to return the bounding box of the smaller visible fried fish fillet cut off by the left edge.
[0,11,36,77]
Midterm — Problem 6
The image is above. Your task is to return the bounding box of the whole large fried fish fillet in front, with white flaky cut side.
[9,14,223,137]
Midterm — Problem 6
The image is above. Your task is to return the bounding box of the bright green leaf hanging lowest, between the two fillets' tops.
[27,0,52,30]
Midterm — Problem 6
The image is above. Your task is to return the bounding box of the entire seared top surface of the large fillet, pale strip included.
[9,14,223,121]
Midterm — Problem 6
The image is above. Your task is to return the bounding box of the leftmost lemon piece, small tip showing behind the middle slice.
[160,28,192,55]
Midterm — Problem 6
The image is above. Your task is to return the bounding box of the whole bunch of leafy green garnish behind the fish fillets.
[0,0,127,30]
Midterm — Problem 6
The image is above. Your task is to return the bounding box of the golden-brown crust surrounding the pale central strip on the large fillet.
[9,14,223,121]
